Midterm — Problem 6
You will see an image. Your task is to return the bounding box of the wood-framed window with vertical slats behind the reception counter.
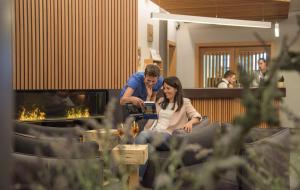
[196,45,270,88]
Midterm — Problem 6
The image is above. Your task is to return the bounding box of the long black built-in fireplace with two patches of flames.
[15,90,109,122]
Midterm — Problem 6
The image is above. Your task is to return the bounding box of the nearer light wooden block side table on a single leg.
[112,144,148,189]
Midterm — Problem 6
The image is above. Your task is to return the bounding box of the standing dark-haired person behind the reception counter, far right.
[252,58,268,87]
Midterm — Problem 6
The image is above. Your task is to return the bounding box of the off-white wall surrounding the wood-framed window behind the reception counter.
[176,12,300,126]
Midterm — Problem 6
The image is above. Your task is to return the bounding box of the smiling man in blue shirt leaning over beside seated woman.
[120,64,163,107]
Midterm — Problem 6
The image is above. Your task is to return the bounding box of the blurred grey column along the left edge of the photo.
[0,0,13,189]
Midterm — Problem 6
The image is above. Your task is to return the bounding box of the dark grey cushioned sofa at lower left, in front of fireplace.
[12,122,103,189]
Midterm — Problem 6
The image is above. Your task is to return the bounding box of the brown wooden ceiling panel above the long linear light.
[152,0,290,20]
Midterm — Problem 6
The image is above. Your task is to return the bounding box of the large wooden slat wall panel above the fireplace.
[13,0,138,90]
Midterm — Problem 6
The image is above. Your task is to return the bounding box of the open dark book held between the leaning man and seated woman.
[126,101,158,119]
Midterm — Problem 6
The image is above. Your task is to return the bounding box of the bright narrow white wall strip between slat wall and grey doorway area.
[138,0,159,70]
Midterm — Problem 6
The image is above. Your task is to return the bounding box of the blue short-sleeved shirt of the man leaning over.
[120,72,164,101]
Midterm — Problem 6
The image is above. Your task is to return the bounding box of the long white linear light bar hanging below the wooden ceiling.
[151,13,272,28]
